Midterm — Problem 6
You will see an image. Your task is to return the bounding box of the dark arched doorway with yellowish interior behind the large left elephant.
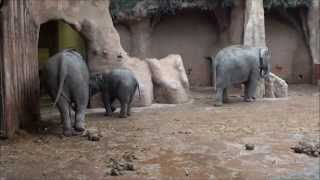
[38,20,87,112]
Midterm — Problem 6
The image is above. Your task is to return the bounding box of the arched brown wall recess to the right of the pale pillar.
[265,13,312,83]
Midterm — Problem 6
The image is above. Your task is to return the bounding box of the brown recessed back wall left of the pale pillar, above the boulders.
[115,8,243,86]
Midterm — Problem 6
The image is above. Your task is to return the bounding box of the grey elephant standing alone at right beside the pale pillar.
[207,45,270,106]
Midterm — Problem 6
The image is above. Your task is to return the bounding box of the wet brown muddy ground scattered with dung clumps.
[0,85,320,180]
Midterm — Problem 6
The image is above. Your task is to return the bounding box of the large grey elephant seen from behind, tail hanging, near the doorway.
[40,49,89,136]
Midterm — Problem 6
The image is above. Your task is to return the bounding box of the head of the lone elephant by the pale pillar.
[259,47,271,78]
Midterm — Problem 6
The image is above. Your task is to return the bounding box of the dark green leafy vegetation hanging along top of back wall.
[110,0,312,18]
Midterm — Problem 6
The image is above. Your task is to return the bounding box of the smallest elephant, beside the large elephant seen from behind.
[90,68,140,118]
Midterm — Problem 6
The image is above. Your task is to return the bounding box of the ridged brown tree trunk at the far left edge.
[0,0,40,137]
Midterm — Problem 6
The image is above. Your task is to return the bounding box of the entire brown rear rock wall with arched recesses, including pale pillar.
[116,0,320,89]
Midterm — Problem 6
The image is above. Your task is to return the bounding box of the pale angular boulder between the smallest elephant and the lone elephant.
[146,55,189,104]
